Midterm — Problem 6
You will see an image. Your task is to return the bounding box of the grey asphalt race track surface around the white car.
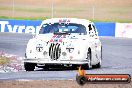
[0,33,132,80]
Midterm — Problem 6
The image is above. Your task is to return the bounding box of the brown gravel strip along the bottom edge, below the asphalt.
[0,80,132,88]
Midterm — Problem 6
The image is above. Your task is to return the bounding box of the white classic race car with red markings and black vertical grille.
[24,18,102,71]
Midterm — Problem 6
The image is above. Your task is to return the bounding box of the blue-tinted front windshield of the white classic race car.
[39,23,87,35]
